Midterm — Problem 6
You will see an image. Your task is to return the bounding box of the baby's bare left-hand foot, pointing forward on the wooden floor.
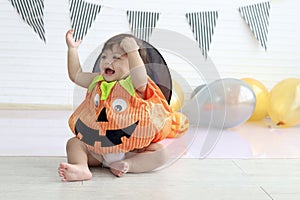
[58,163,92,181]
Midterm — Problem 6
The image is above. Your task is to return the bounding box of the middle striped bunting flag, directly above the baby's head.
[127,11,159,42]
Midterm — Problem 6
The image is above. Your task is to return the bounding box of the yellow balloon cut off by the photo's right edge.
[268,78,300,127]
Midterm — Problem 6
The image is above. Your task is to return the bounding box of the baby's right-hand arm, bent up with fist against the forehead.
[120,37,147,97]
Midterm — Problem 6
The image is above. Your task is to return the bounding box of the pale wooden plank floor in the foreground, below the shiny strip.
[0,157,300,200]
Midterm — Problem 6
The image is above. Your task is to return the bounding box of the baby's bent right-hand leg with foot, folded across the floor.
[110,143,168,176]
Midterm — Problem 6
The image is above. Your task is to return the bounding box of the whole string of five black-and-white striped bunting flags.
[8,0,270,55]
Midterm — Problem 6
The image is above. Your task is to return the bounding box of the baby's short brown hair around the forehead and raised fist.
[100,34,149,63]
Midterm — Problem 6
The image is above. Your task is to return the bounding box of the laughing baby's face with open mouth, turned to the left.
[100,44,129,82]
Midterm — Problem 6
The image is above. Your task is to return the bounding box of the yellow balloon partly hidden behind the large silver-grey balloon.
[242,78,269,121]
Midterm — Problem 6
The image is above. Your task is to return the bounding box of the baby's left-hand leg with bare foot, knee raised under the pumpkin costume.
[58,137,92,181]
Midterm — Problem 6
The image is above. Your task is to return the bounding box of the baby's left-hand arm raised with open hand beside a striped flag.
[66,30,97,88]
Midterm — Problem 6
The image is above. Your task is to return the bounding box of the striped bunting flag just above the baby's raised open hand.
[69,0,101,41]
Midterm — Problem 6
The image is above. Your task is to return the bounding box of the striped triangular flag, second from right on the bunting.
[186,11,218,58]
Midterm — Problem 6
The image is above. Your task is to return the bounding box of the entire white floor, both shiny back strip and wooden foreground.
[0,110,300,200]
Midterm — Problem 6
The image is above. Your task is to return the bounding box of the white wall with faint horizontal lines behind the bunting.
[0,0,300,108]
